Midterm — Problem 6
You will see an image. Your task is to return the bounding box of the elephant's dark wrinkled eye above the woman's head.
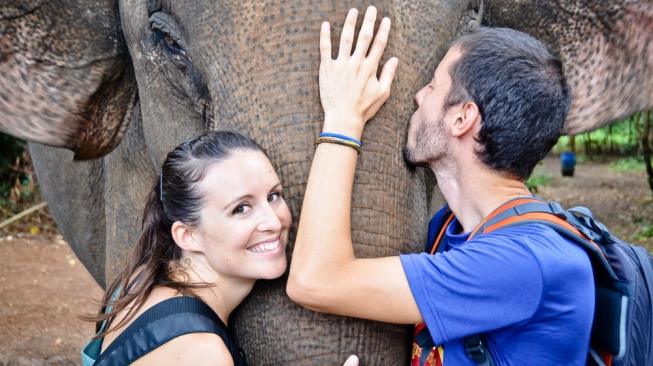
[150,11,192,68]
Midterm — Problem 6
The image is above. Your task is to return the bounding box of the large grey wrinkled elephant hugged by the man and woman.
[0,0,653,365]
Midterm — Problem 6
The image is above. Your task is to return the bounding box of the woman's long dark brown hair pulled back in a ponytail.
[82,131,263,338]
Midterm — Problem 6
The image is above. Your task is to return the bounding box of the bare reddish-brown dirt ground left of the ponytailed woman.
[0,235,102,366]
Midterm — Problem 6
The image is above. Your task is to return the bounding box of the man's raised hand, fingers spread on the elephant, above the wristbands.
[320,6,398,139]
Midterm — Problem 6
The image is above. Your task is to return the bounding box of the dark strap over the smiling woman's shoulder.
[95,296,246,366]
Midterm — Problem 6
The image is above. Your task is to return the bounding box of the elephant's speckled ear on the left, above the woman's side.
[0,0,137,159]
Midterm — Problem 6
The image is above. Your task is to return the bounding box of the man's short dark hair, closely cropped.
[446,27,570,180]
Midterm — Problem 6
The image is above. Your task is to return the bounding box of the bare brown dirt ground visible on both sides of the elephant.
[0,158,653,366]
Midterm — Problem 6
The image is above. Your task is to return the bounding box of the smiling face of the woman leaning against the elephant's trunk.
[190,150,292,279]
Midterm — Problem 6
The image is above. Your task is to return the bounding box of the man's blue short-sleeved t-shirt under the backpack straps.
[401,209,594,366]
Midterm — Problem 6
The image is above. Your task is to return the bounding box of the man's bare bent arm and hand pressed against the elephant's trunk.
[287,7,422,324]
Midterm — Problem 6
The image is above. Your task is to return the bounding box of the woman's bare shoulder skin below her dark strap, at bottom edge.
[134,333,234,366]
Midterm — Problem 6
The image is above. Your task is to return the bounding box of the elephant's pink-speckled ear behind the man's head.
[483,0,653,134]
